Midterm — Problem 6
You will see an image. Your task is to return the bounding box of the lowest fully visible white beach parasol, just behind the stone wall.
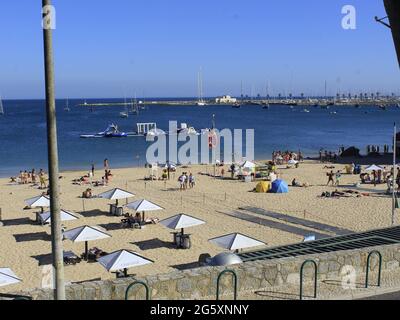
[97,250,154,277]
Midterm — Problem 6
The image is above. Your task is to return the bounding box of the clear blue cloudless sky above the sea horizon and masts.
[0,0,400,98]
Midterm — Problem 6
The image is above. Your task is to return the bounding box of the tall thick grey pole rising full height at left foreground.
[42,0,65,300]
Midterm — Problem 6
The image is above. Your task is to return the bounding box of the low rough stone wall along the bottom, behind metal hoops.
[9,245,400,300]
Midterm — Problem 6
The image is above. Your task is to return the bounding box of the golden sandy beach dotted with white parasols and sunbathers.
[0,161,391,292]
